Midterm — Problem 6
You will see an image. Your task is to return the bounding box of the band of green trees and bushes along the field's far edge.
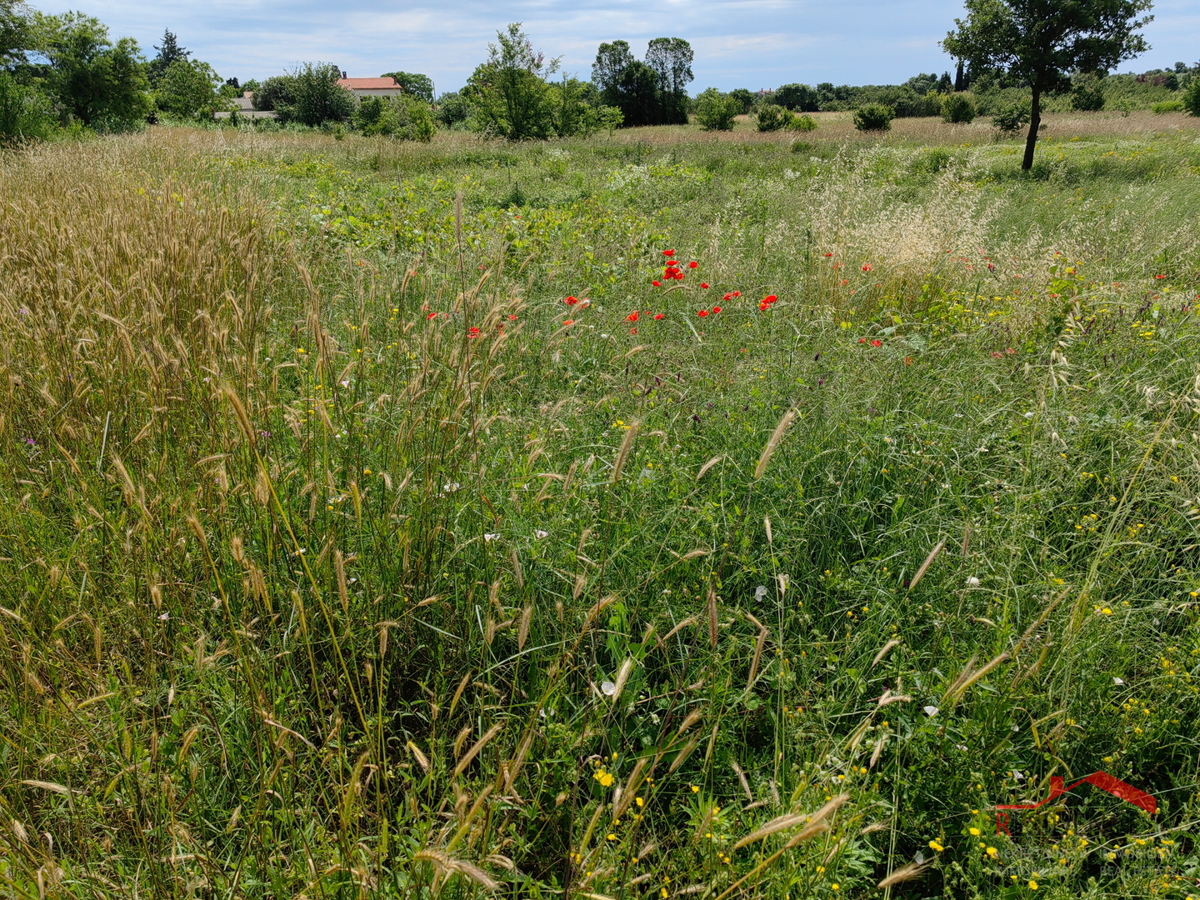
[7,0,1200,168]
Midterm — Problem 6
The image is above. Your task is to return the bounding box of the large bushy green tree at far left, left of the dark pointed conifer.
[35,12,151,131]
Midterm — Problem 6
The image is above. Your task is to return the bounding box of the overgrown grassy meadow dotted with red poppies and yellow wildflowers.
[7,113,1200,900]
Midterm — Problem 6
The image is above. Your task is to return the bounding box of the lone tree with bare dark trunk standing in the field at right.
[942,0,1152,170]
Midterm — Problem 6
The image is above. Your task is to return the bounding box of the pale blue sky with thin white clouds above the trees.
[44,0,1200,94]
